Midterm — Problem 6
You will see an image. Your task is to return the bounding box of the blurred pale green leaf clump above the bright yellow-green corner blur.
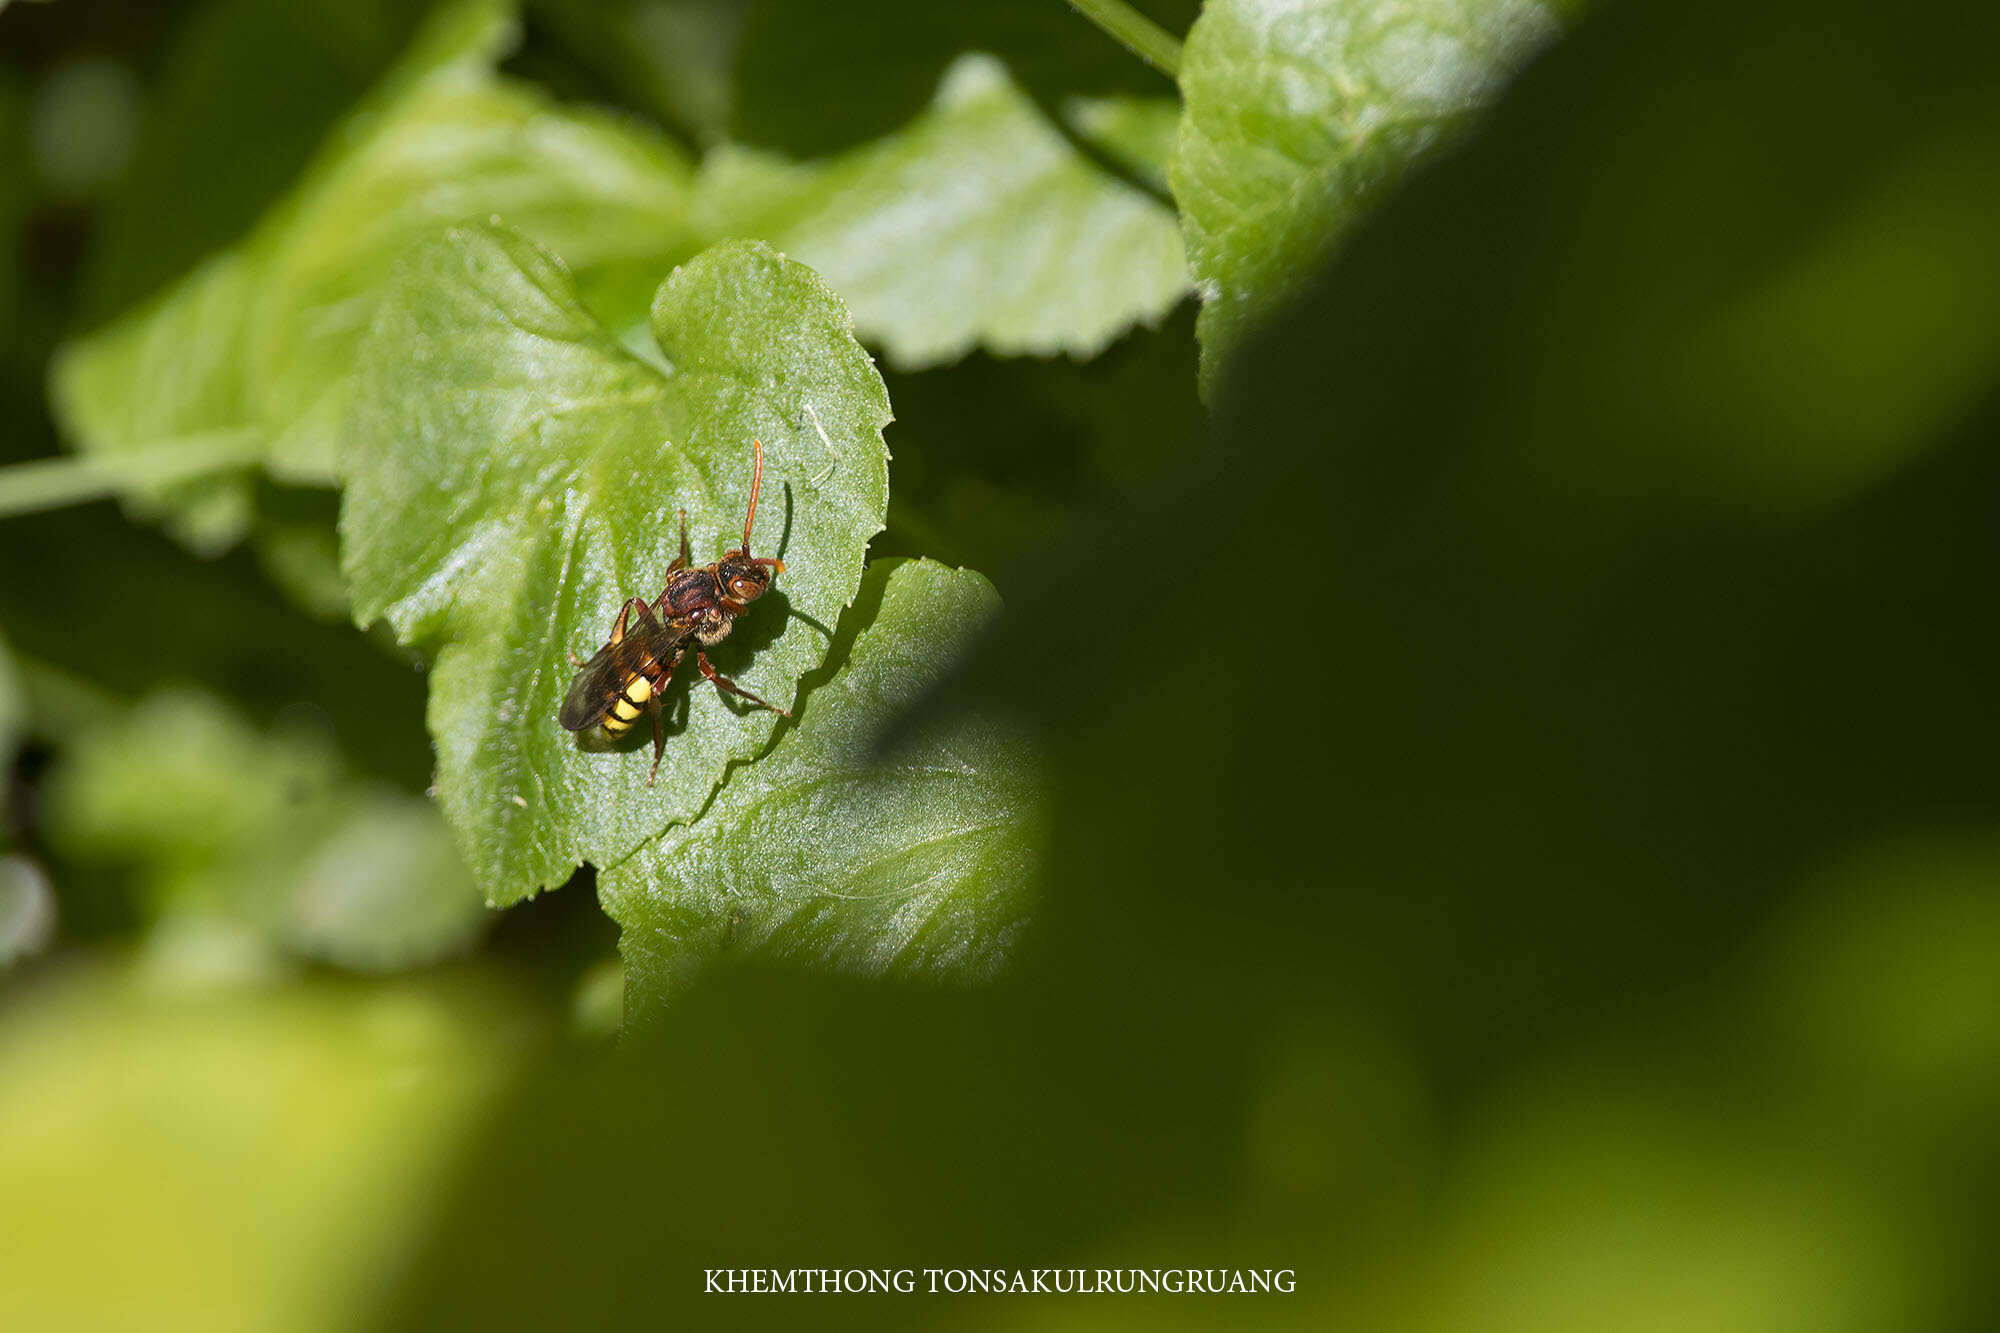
[48,693,486,971]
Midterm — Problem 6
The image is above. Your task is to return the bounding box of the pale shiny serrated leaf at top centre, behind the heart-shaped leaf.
[696,56,1188,368]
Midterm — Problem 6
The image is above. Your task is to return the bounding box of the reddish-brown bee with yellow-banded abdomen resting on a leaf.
[556,440,792,787]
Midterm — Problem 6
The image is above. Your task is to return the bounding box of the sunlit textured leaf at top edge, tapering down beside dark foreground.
[1172,0,1556,384]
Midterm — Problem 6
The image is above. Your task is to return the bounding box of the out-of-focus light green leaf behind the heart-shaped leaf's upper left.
[52,2,688,548]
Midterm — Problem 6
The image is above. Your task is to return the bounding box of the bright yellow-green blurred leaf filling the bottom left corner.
[0,967,548,1333]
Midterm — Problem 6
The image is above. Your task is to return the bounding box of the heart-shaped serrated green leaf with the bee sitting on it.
[340,226,890,903]
